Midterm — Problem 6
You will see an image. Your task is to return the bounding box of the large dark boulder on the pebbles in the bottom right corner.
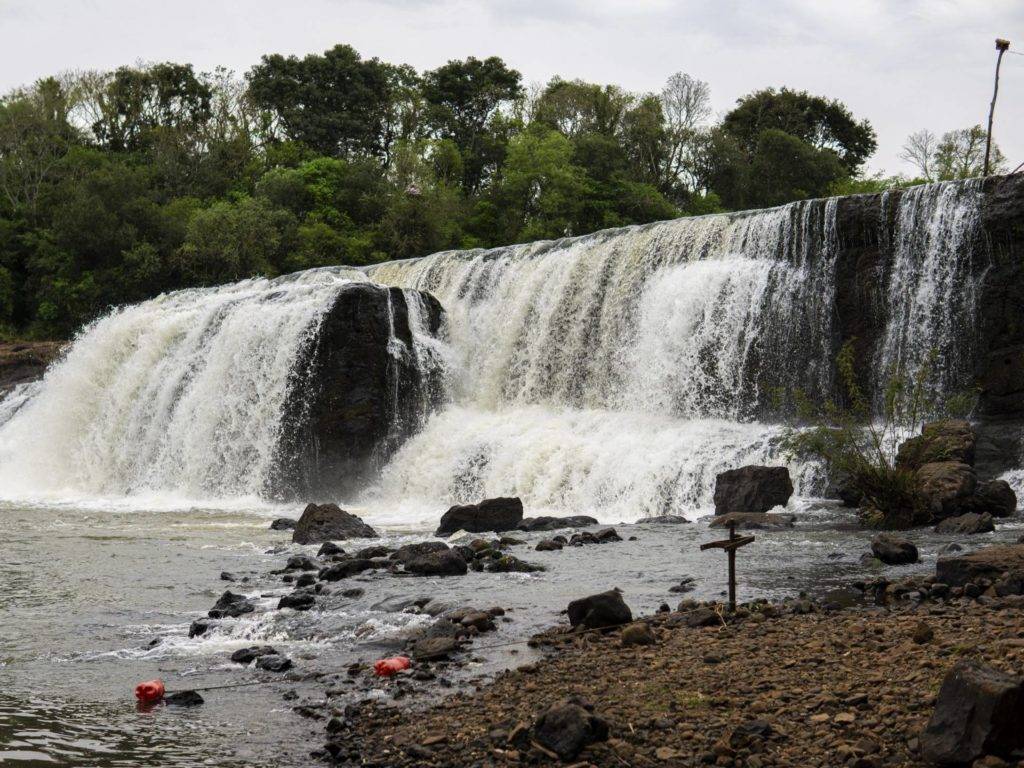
[921,660,1024,765]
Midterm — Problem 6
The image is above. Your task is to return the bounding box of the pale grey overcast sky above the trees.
[0,0,1024,172]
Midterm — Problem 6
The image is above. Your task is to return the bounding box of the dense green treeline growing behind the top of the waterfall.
[0,45,966,337]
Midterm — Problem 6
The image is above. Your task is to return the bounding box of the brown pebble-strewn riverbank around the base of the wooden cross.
[328,601,1024,768]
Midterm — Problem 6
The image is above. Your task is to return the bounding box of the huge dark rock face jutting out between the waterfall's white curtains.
[269,282,444,498]
